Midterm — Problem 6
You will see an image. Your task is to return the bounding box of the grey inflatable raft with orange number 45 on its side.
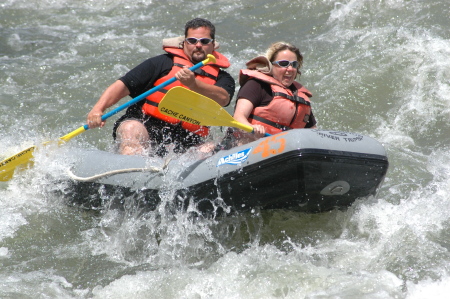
[65,129,389,214]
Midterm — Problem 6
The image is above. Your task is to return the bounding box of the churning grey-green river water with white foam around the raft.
[0,0,450,298]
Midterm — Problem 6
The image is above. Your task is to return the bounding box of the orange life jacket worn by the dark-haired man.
[142,47,230,137]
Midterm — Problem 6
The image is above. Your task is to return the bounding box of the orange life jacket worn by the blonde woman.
[239,69,312,134]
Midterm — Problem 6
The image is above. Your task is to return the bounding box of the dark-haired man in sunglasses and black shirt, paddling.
[87,18,235,156]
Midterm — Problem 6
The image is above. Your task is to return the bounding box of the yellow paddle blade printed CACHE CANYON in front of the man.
[158,86,253,132]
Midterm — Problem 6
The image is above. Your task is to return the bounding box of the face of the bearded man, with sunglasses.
[184,27,214,64]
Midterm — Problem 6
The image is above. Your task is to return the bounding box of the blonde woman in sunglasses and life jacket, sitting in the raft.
[229,42,316,144]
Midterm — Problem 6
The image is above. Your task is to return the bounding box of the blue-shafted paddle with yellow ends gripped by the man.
[0,54,216,182]
